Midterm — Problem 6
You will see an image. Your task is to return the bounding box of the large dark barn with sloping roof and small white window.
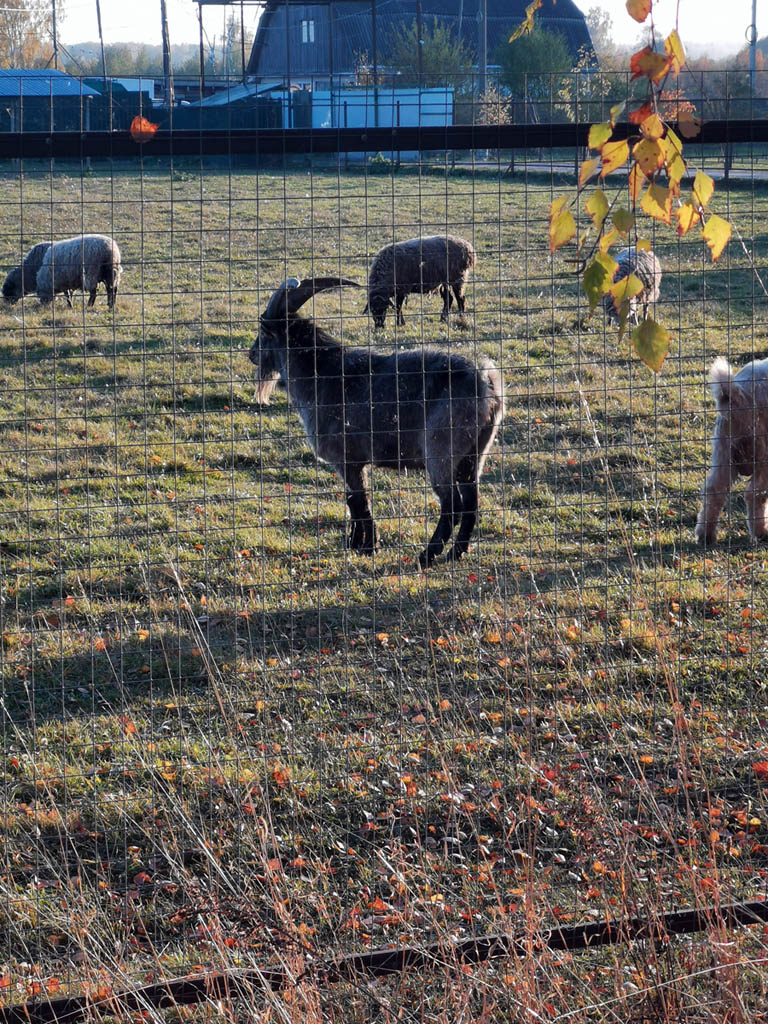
[248,0,592,82]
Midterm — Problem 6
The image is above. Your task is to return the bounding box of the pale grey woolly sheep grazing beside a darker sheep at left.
[37,234,122,309]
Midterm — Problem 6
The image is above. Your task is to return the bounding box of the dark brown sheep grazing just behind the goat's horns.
[364,234,475,327]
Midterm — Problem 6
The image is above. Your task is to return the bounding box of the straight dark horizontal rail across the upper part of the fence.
[0,120,768,160]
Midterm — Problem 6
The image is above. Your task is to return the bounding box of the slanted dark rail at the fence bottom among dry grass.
[0,900,768,1024]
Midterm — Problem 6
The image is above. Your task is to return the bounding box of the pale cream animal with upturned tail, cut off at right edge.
[696,358,768,544]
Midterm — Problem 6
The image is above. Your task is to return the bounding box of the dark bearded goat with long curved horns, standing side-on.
[249,278,504,567]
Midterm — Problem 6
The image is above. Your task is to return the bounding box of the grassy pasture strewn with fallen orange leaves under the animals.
[0,155,768,1022]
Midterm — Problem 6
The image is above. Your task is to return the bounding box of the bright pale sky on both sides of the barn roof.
[60,0,768,56]
